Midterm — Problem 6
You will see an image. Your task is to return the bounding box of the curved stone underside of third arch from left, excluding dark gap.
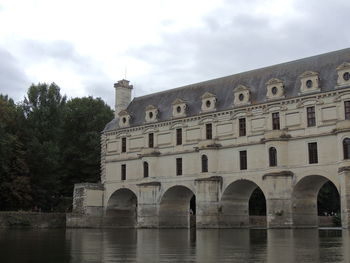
[219,179,266,227]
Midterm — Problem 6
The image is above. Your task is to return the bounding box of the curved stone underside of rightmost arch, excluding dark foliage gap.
[292,175,339,227]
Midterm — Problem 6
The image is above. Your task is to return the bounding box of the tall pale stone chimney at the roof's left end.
[114,79,133,118]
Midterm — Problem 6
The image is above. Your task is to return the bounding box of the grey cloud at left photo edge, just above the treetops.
[0,48,30,101]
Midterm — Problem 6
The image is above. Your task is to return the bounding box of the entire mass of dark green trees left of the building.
[0,83,113,211]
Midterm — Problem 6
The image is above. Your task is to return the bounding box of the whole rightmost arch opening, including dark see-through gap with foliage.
[292,175,341,227]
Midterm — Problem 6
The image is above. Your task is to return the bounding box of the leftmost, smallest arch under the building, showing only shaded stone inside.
[104,188,137,228]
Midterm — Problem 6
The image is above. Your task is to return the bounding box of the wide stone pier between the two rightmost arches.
[263,171,293,228]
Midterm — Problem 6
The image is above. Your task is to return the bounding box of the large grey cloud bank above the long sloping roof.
[129,0,350,98]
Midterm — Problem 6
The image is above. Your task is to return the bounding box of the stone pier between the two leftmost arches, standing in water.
[137,182,161,228]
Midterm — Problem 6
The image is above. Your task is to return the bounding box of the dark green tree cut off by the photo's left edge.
[0,95,32,210]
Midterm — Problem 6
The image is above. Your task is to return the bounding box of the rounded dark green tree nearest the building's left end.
[61,97,113,200]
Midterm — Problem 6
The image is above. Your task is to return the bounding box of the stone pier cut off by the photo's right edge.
[338,166,350,228]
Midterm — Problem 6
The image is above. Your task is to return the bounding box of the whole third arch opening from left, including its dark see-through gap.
[220,180,266,227]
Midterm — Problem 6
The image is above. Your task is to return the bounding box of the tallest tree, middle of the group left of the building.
[23,83,66,211]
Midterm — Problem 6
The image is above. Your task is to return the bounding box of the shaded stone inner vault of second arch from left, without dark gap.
[159,185,195,228]
